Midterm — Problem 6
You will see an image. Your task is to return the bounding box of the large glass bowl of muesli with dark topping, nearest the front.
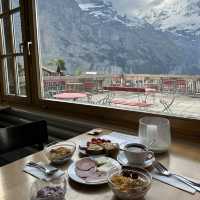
[108,168,152,200]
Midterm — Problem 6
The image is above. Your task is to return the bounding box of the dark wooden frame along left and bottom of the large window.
[0,0,200,140]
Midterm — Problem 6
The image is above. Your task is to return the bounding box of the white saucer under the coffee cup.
[117,151,155,168]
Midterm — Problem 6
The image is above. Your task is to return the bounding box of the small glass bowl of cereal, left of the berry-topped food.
[44,141,76,165]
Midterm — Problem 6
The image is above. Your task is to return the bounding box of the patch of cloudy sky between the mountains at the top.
[107,0,164,16]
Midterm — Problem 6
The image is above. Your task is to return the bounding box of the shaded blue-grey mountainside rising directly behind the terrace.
[38,0,200,74]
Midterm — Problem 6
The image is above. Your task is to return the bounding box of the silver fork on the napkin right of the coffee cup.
[153,161,200,192]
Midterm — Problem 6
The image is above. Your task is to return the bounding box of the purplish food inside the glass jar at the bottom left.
[36,186,65,200]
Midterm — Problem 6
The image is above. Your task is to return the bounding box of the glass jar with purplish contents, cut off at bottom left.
[30,175,67,200]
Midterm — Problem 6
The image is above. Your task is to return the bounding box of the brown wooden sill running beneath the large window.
[0,101,200,141]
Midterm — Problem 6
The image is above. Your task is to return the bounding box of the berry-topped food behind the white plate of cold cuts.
[80,138,119,157]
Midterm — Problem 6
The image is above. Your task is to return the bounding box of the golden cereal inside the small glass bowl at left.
[49,147,72,161]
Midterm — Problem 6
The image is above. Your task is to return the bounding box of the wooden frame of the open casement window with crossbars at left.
[0,0,31,105]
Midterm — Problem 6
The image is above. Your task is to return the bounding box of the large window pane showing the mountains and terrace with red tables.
[36,0,200,117]
